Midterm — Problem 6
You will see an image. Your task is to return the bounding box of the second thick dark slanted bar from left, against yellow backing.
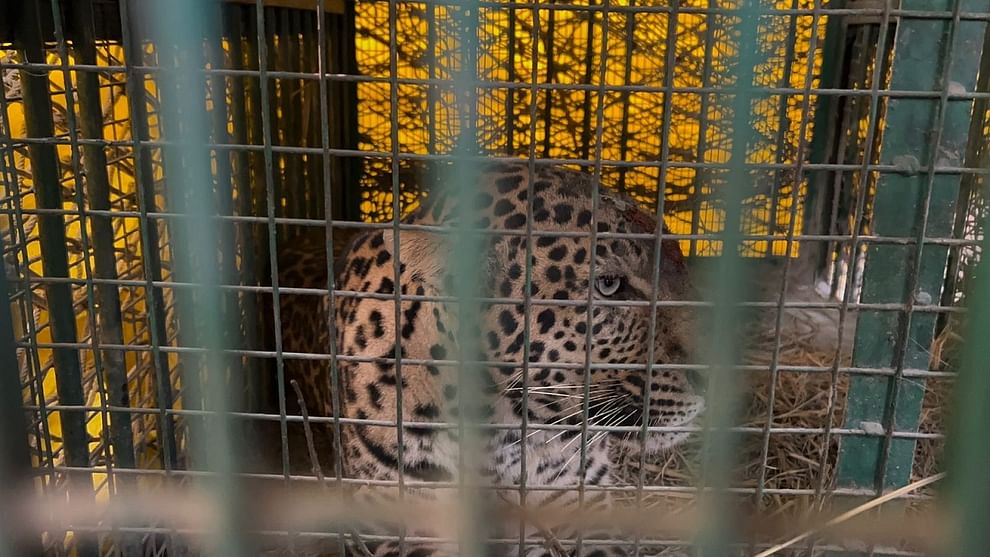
[67,0,135,483]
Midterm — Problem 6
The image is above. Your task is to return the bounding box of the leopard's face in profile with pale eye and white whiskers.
[472,162,703,452]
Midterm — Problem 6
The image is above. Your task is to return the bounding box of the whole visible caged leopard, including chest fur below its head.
[286,161,705,557]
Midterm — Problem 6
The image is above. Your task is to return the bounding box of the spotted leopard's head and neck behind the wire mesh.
[338,159,703,484]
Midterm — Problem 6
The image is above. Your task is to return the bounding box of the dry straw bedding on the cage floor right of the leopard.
[616,256,961,548]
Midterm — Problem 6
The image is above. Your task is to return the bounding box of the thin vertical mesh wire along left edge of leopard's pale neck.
[316,0,346,555]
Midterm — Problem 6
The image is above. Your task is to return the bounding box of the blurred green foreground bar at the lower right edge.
[942,176,990,557]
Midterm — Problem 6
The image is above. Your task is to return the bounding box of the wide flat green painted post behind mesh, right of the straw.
[836,0,986,552]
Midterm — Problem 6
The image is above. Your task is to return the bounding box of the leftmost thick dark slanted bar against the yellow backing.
[11,2,99,557]
